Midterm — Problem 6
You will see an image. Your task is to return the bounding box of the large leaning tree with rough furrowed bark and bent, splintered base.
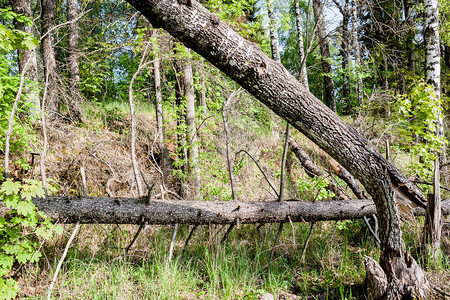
[128,0,430,299]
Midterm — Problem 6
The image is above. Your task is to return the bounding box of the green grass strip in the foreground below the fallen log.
[22,222,382,299]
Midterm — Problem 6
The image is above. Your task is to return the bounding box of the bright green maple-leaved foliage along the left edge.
[0,9,59,299]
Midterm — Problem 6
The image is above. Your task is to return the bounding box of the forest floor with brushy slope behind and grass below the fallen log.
[10,99,450,299]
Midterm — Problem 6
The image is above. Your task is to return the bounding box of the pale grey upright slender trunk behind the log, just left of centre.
[183,55,200,199]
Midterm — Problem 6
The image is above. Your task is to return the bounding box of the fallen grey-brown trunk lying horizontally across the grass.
[1,197,450,225]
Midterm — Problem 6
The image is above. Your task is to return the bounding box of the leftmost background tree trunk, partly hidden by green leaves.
[11,0,40,118]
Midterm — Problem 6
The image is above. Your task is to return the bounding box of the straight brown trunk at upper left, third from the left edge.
[67,0,82,123]
